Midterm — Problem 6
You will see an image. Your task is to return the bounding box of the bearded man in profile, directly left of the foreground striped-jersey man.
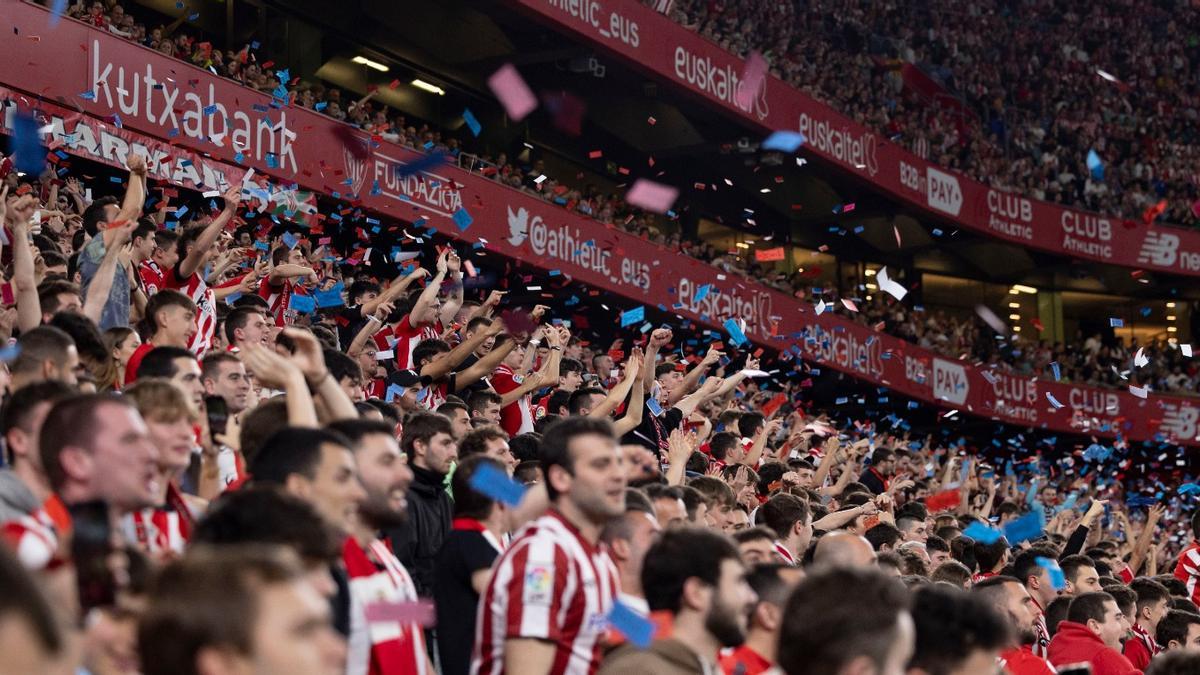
[329,419,433,673]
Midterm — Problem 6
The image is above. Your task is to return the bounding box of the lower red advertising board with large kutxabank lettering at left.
[0,2,1200,446]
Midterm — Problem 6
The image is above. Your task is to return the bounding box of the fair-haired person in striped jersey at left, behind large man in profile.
[122,377,208,560]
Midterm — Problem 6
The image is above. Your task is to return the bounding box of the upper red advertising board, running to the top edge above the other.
[515,0,1200,276]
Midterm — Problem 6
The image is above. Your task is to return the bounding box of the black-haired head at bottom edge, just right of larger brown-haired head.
[908,585,1009,675]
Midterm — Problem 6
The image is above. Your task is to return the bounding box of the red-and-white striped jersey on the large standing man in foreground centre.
[470,509,619,675]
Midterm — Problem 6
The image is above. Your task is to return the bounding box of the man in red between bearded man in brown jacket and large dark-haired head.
[721,555,804,675]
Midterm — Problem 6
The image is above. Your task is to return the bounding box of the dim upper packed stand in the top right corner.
[662,0,1200,226]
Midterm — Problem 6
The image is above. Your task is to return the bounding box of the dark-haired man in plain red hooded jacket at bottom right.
[1050,591,1140,675]
